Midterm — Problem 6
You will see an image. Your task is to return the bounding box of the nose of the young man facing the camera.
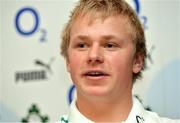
[88,44,104,64]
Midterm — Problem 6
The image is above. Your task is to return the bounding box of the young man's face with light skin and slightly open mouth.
[67,16,142,100]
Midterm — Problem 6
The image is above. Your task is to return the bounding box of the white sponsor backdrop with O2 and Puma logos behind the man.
[0,0,180,122]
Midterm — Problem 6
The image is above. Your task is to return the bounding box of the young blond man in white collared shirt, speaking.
[60,0,180,123]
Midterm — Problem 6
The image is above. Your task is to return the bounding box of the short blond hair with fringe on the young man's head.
[61,0,147,82]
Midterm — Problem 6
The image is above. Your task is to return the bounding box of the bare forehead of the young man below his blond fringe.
[70,15,133,40]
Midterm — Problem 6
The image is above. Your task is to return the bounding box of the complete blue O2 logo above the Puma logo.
[15,7,47,42]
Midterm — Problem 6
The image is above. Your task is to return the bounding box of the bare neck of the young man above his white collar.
[77,92,132,122]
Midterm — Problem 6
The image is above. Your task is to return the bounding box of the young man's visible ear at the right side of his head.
[133,54,143,73]
